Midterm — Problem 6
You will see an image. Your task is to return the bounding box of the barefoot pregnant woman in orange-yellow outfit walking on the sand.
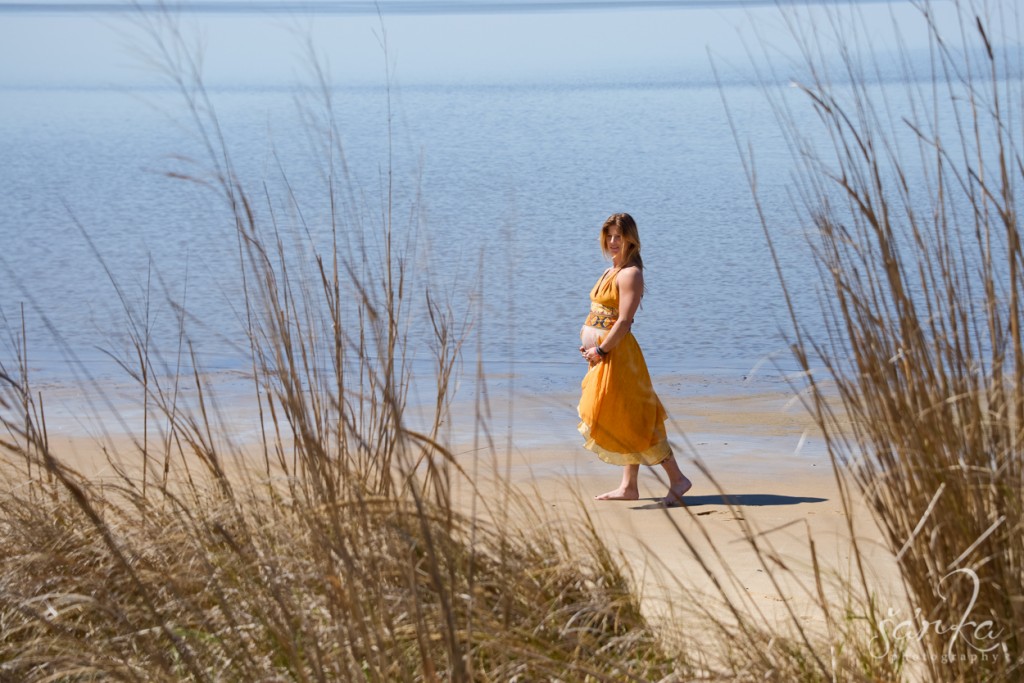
[580,213,692,505]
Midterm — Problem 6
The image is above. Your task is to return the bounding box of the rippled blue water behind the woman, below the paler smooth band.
[0,7,1015,403]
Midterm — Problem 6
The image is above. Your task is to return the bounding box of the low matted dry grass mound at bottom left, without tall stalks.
[0,450,679,681]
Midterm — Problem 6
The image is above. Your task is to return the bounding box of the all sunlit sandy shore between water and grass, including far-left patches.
[14,368,899,643]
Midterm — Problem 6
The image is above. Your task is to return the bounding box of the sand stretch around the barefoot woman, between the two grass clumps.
[448,385,903,631]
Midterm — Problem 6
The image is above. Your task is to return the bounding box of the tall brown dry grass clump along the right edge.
[729,1,1024,681]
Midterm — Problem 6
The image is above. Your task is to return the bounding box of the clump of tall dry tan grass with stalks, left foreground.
[0,10,689,681]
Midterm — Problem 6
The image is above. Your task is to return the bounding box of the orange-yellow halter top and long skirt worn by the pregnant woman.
[579,269,672,465]
